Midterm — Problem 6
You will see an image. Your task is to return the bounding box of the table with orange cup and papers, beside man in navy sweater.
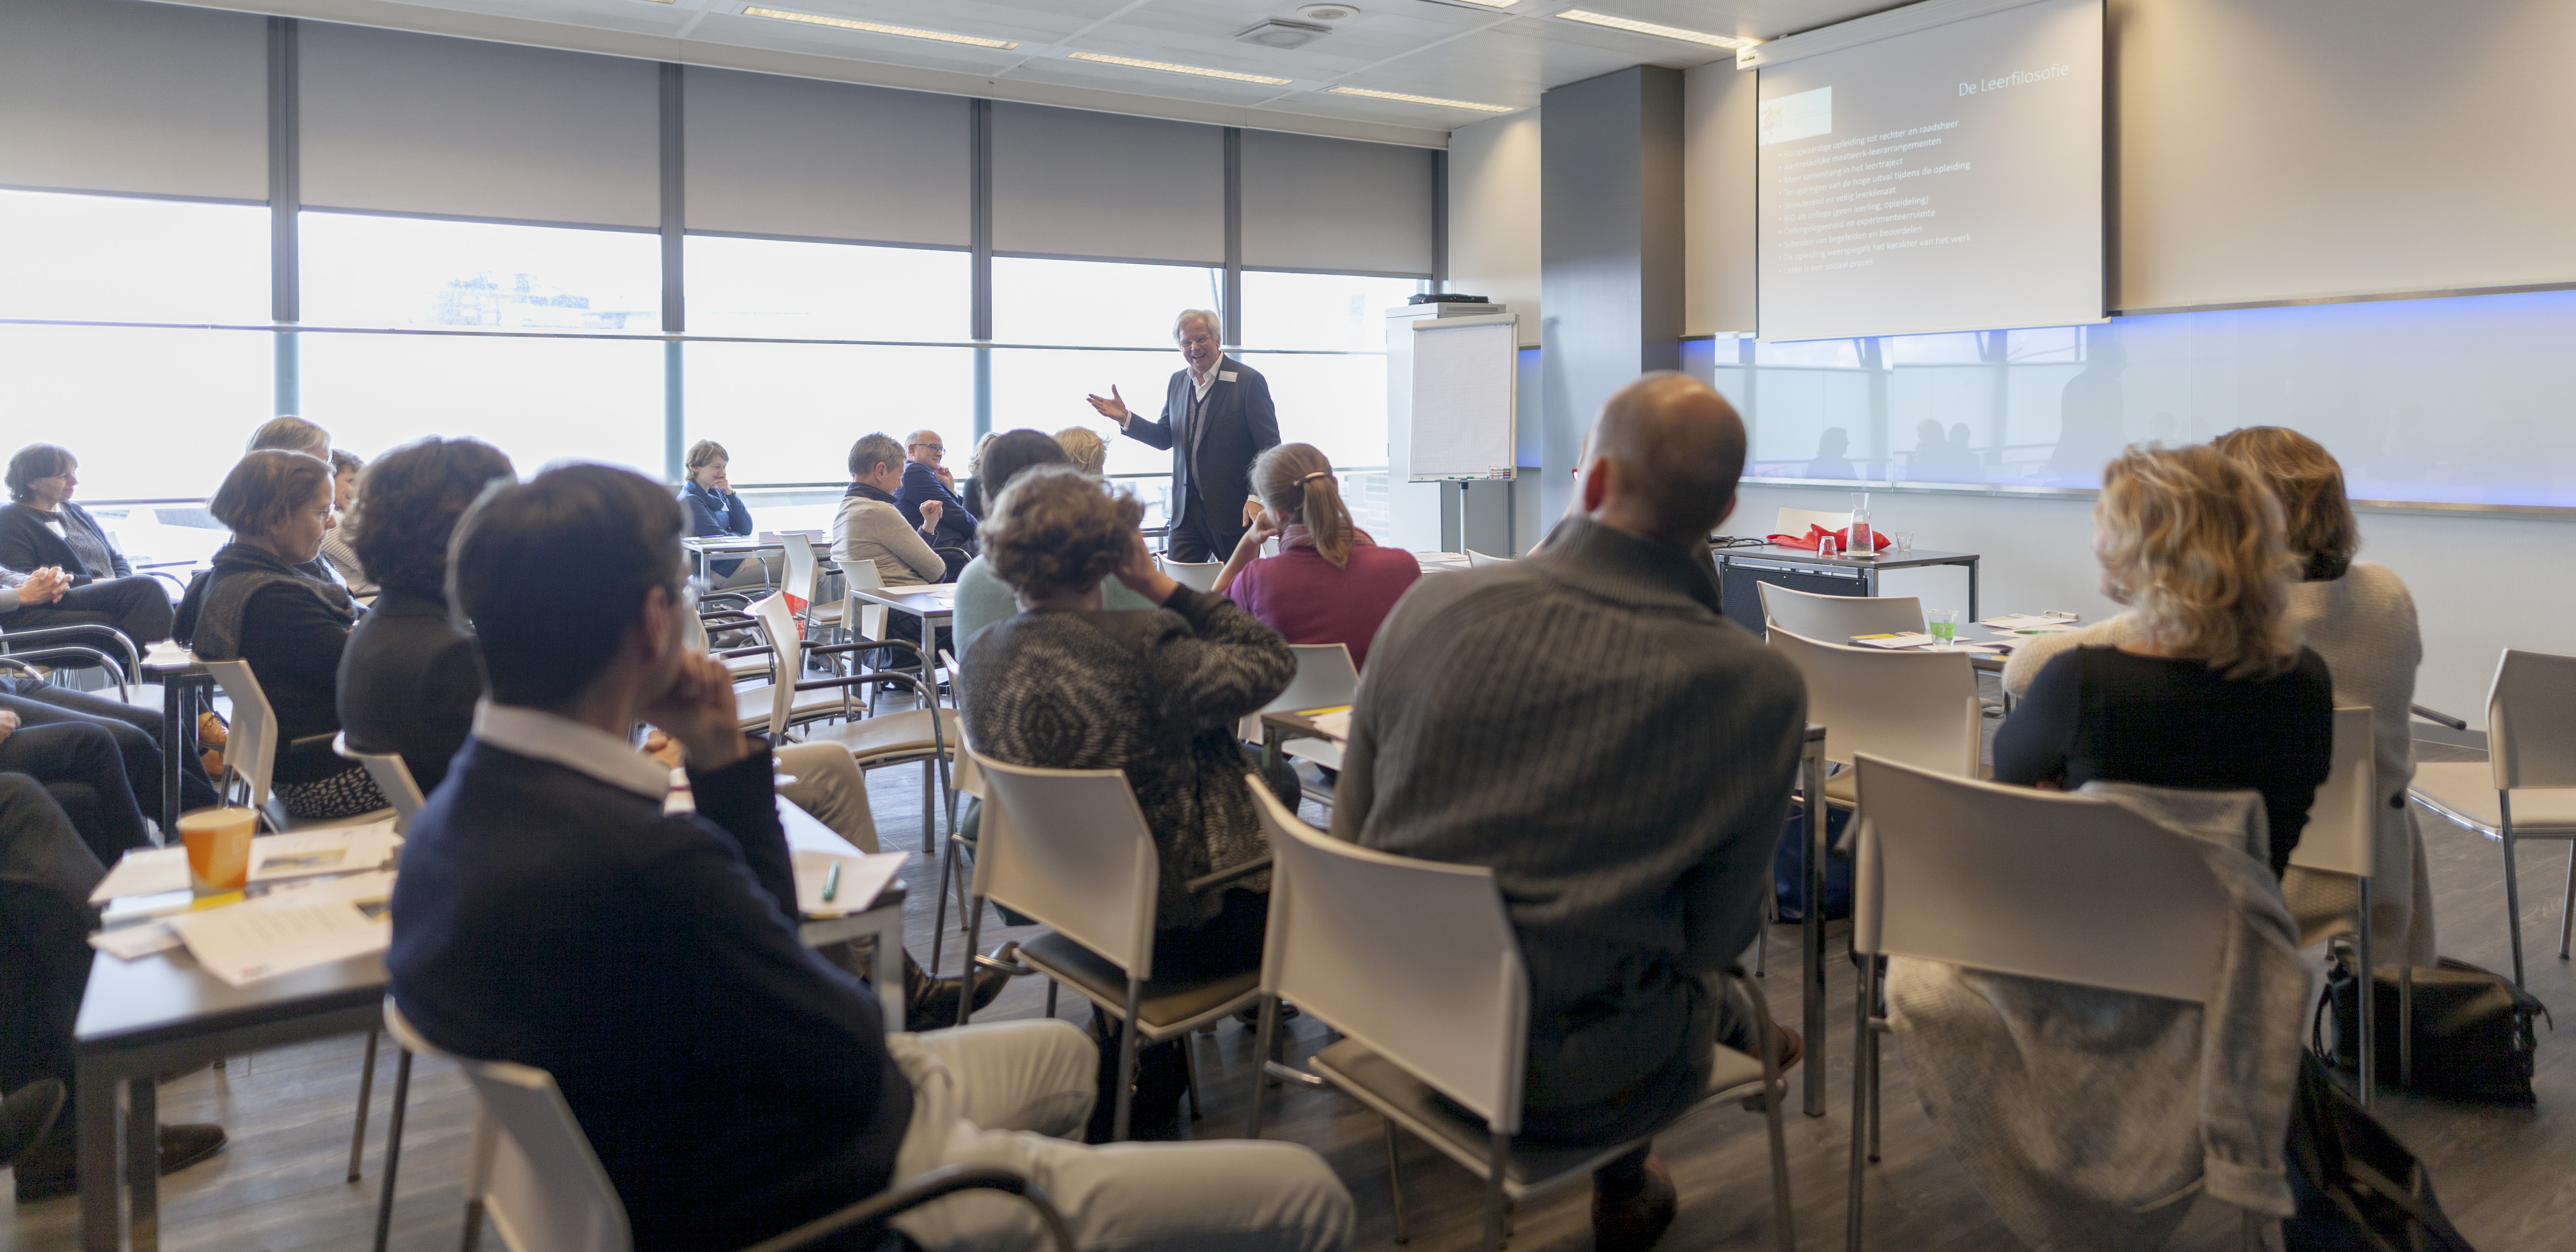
[72,798,907,1252]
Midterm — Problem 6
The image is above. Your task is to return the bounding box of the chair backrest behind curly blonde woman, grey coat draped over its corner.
[1854,757,2233,1002]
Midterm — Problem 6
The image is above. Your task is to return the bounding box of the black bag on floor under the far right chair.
[2308,948,2558,1108]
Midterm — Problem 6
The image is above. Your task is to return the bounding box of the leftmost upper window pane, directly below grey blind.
[0,191,268,325]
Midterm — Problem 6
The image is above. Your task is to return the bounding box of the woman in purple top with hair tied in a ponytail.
[1216,443,1422,665]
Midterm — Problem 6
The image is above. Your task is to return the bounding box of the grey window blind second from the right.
[992,100,1226,266]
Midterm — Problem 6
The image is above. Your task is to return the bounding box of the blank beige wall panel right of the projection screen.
[2110,0,2576,309]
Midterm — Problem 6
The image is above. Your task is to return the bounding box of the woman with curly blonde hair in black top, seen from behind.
[1994,446,2334,873]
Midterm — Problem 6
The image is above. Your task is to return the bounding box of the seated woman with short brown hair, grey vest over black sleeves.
[178,448,384,819]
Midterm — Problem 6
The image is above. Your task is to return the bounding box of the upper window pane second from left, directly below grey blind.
[301,211,662,335]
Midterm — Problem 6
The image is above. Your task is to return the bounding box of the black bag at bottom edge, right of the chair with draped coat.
[2280,1051,2476,1252]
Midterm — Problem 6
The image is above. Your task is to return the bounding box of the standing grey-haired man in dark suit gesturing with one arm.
[1087,309,1280,562]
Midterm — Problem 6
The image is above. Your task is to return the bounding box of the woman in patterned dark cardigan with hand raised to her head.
[961,464,1296,1126]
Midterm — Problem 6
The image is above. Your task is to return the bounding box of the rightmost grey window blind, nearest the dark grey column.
[1244,131,1432,276]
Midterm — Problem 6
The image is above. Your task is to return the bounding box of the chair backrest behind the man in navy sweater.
[384,997,634,1252]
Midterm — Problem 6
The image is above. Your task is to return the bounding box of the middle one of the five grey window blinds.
[680,67,974,247]
